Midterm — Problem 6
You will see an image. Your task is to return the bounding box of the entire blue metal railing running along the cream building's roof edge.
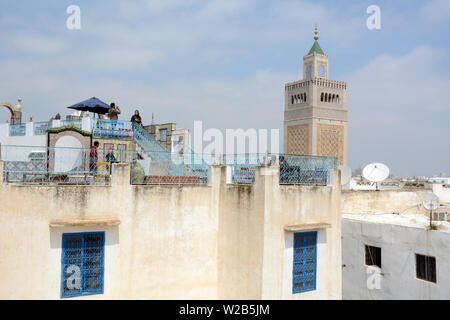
[0,146,337,186]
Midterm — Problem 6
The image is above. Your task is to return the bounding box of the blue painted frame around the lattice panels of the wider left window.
[60,231,105,299]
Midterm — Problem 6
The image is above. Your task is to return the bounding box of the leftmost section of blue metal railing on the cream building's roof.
[1,146,111,185]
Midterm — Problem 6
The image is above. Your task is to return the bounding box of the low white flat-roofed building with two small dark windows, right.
[342,213,450,300]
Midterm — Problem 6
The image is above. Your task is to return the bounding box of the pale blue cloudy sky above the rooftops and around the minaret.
[0,0,450,176]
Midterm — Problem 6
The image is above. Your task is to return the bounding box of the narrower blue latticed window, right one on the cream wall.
[292,231,317,293]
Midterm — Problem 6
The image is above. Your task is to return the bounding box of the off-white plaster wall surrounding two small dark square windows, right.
[342,215,450,300]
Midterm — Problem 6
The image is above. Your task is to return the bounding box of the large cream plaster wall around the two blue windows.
[0,161,341,299]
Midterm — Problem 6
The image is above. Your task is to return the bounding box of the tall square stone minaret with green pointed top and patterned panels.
[284,26,348,165]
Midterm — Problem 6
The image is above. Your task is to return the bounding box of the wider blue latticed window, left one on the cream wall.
[61,232,105,298]
